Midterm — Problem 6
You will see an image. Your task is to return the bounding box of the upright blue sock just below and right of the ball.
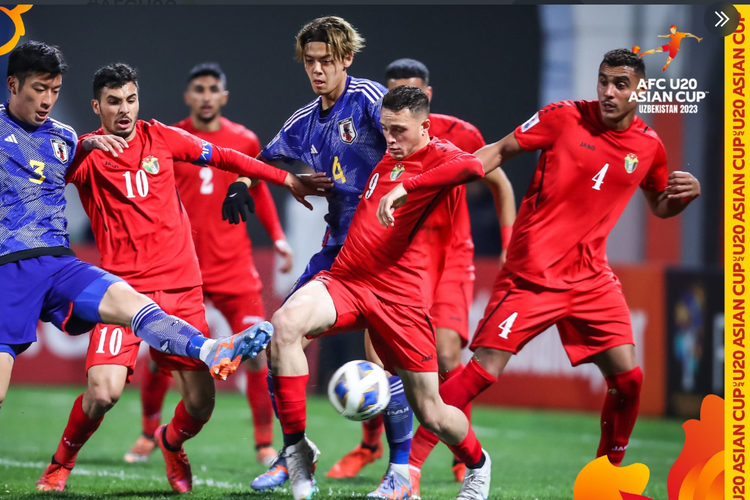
[383,375,414,464]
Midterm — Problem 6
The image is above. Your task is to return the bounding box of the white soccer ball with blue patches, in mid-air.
[328,361,391,422]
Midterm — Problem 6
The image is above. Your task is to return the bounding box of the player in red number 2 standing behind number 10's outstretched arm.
[125,63,293,465]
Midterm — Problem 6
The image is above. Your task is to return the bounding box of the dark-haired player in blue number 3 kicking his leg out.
[0,41,271,418]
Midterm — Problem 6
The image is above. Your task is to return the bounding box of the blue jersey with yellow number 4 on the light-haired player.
[260,76,386,246]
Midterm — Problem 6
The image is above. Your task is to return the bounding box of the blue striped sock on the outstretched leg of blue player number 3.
[130,302,208,358]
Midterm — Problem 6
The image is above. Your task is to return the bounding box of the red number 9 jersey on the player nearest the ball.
[331,138,481,309]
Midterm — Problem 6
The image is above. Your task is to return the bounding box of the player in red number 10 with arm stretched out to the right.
[37,63,318,492]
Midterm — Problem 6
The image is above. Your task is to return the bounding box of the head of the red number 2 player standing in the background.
[185,62,229,123]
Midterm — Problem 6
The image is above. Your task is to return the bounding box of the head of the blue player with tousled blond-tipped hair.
[296,16,365,99]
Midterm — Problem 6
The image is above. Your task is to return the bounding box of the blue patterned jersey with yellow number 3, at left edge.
[0,102,78,263]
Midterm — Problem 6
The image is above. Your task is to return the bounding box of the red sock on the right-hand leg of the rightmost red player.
[596,366,643,466]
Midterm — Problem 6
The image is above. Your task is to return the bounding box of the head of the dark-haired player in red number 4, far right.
[596,49,646,128]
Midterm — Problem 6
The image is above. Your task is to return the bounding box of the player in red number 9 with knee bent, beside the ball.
[270,86,491,500]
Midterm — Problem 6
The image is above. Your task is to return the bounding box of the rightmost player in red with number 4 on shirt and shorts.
[412,49,700,474]
